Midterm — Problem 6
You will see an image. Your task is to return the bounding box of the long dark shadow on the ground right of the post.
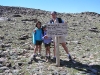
[60,60,100,75]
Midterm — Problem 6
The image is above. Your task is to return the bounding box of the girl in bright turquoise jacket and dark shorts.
[32,21,42,60]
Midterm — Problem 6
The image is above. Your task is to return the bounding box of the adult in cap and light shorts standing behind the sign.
[49,11,72,61]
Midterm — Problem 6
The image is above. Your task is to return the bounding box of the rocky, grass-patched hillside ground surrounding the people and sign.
[0,6,100,75]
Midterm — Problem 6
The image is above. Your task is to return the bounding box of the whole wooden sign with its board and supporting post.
[46,23,67,67]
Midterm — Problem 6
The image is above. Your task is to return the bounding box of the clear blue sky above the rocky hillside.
[0,0,100,14]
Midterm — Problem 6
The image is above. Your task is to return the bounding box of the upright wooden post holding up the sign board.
[55,36,60,67]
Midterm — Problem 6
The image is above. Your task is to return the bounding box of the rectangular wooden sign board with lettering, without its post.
[46,23,67,36]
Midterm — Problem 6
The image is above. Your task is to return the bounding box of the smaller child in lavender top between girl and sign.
[42,25,52,61]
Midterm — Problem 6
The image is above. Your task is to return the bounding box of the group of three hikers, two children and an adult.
[27,11,72,63]
